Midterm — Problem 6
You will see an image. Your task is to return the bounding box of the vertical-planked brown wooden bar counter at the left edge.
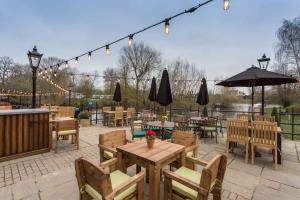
[0,109,52,162]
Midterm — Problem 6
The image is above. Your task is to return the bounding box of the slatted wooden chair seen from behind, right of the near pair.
[251,121,277,169]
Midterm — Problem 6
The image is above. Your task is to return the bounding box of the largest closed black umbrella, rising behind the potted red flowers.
[156,69,173,112]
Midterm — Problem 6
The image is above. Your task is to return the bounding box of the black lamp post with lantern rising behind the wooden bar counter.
[27,46,43,108]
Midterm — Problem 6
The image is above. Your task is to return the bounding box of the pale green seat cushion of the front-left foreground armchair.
[80,170,136,200]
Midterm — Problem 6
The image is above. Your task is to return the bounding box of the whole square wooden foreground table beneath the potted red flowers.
[117,139,185,200]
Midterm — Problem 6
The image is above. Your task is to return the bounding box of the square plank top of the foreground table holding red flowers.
[117,139,185,165]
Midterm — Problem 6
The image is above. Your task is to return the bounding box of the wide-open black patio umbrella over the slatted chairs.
[217,65,298,118]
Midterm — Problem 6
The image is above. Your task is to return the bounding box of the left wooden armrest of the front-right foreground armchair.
[163,169,208,195]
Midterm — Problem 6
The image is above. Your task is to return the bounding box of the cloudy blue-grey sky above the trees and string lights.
[0,0,300,88]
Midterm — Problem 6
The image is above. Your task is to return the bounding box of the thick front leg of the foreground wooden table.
[149,165,160,200]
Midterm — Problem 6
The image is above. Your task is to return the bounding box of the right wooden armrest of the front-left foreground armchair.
[105,172,145,199]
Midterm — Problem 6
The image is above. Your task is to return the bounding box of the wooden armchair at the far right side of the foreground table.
[170,130,199,169]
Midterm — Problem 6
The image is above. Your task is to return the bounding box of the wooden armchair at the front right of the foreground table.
[164,155,227,200]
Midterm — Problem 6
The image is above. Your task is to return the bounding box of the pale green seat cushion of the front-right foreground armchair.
[172,167,201,200]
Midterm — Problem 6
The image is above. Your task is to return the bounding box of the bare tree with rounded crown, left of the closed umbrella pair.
[120,43,161,106]
